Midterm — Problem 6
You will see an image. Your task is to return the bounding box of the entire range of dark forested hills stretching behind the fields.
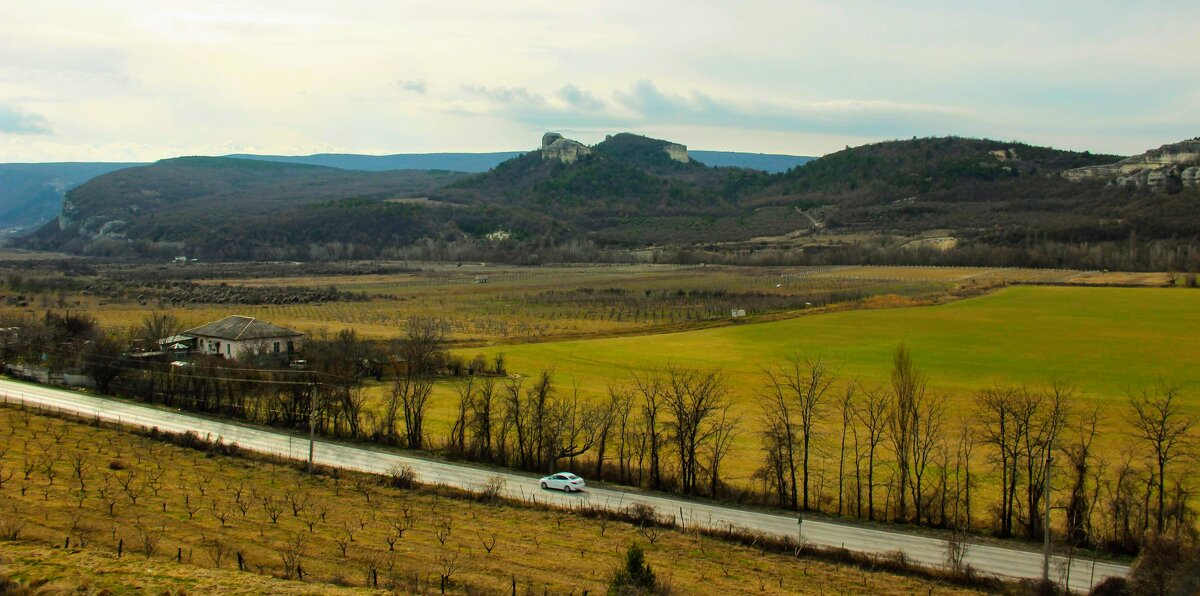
[28,134,1200,266]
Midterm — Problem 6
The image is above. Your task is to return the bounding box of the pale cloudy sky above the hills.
[0,0,1200,162]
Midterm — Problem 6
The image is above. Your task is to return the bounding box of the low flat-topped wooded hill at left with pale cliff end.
[28,157,463,259]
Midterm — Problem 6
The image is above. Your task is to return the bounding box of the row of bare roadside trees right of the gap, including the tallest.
[756,345,1198,552]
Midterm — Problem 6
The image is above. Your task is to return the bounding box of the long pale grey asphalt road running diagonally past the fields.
[0,380,1129,591]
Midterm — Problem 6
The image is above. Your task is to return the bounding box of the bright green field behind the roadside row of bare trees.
[470,287,1200,404]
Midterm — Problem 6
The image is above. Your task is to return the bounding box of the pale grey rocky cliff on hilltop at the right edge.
[1062,138,1200,191]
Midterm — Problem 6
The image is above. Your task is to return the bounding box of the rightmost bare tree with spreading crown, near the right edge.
[1129,383,1196,534]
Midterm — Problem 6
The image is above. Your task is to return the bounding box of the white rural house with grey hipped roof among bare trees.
[174,314,304,359]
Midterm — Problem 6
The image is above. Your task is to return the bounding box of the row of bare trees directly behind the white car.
[446,366,738,495]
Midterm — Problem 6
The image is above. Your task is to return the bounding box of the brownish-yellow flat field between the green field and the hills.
[0,263,1123,343]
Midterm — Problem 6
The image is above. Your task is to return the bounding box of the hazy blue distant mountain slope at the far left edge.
[0,163,139,236]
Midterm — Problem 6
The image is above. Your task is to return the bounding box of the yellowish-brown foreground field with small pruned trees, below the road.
[0,407,984,594]
